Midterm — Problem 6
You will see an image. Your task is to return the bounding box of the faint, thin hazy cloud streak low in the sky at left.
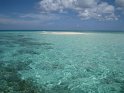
[0,13,60,25]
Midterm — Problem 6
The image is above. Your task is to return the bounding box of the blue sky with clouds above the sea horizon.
[0,0,124,31]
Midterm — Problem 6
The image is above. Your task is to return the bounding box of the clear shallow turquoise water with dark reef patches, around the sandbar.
[0,32,124,93]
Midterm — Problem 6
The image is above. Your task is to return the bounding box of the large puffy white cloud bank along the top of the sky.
[40,0,117,20]
